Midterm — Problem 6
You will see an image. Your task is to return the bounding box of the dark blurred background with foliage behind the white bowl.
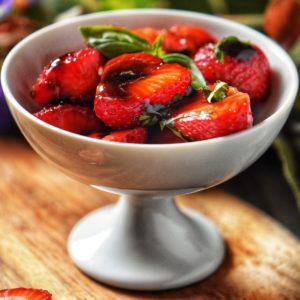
[0,0,300,236]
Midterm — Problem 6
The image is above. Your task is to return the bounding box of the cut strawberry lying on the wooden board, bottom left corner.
[0,288,52,300]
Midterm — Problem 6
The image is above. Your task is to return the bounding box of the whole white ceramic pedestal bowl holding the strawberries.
[2,9,298,289]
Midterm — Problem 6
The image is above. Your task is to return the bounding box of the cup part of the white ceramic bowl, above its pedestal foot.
[2,9,298,191]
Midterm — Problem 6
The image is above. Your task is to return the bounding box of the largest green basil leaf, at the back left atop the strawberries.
[80,25,152,58]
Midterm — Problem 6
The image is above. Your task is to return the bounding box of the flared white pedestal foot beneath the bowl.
[68,196,225,291]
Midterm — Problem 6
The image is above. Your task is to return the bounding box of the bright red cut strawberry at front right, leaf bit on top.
[165,84,252,141]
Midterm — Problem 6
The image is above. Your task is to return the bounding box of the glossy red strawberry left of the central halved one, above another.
[31,48,101,105]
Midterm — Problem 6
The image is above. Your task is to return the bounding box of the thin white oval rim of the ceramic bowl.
[1,8,298,150]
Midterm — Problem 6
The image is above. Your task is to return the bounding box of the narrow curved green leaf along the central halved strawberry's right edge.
[161,53,206,90]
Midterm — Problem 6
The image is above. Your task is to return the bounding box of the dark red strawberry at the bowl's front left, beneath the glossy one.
[34,104,104,134]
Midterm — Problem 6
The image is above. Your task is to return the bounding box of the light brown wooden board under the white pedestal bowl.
[0,138,300,300]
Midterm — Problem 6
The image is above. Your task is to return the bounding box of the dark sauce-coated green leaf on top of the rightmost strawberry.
[214,36,255,63]
